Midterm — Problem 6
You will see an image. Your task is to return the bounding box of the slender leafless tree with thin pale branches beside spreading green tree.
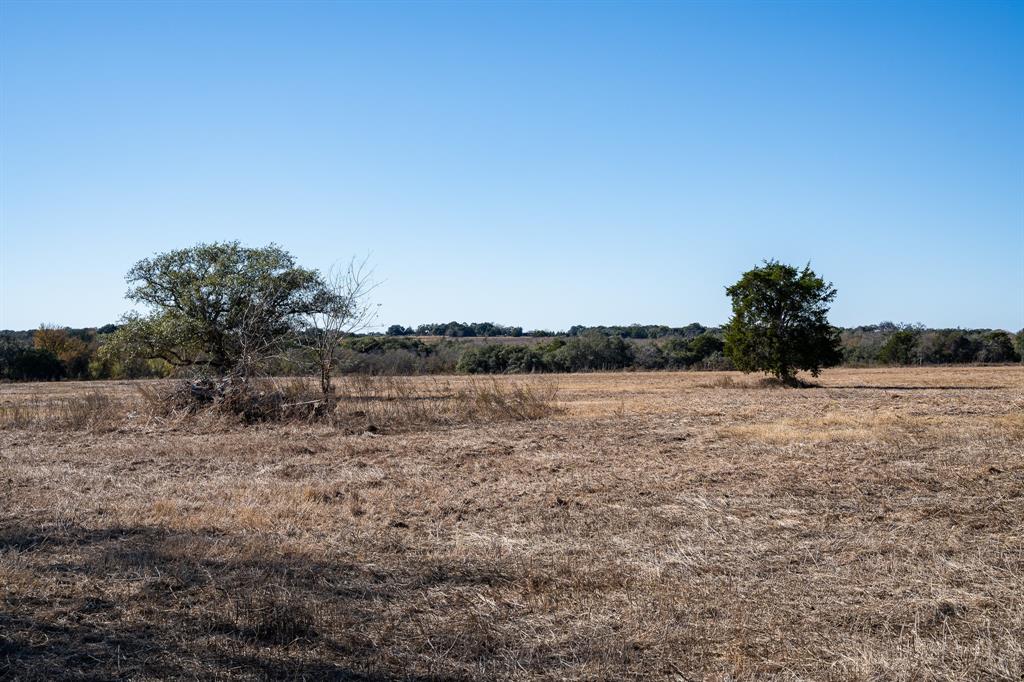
[299,258,378,403]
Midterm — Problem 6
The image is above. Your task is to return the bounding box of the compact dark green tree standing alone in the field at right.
[725,260,843,384]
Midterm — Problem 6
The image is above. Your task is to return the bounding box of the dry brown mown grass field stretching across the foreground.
[0,368,1024,680]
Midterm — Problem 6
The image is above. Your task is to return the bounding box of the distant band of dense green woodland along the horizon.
[0,322,1024,381]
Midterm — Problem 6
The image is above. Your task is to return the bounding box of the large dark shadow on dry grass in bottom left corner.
[0,525,505,681]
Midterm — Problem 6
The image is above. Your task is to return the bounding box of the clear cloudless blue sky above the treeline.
[0,0,1024,330]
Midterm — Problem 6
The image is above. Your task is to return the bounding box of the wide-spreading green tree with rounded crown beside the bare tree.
[104,242,331,375]
